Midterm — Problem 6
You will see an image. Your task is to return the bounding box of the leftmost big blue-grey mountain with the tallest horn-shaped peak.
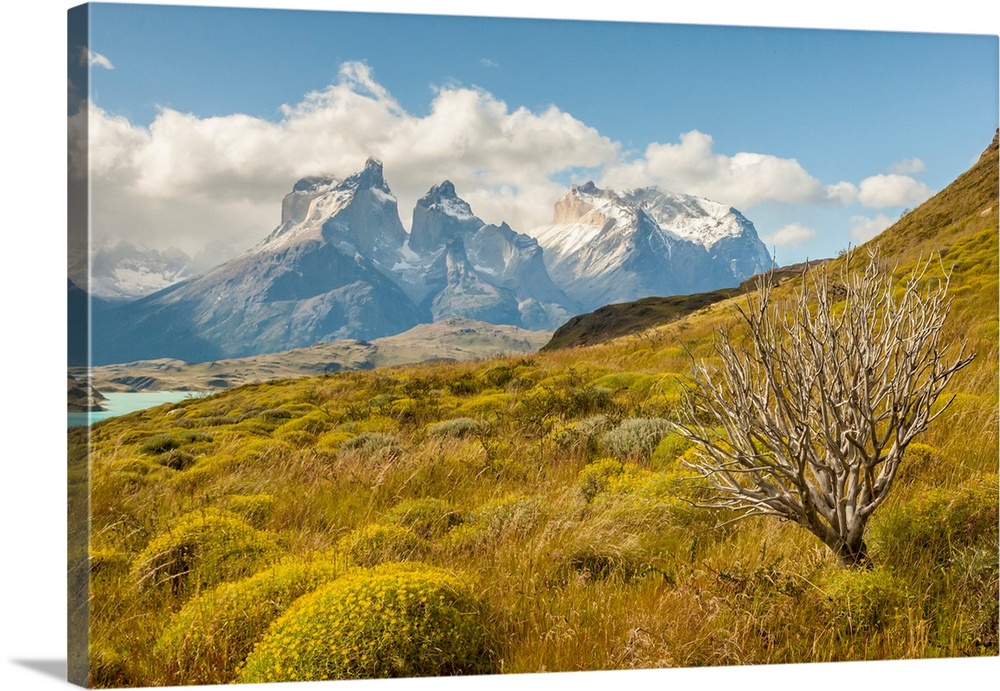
[94,161,429,364]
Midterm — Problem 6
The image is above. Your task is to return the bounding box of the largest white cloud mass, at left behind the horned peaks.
[84,62,619,262]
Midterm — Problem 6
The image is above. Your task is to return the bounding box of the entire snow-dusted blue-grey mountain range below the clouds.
[86,159,772,364]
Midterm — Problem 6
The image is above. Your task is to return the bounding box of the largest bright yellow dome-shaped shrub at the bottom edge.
[237,564,495,683]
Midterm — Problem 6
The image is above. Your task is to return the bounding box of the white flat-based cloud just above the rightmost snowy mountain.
[602,130,825,208]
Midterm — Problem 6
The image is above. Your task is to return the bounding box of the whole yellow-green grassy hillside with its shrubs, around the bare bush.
[70,131,1000,686]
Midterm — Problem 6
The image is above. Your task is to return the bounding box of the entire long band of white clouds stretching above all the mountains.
[78,62,930,268]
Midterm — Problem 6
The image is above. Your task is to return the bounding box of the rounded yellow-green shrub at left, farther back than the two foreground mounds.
[131,509,279,595]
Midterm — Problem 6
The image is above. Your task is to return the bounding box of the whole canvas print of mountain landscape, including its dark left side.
[67,3,1000,688]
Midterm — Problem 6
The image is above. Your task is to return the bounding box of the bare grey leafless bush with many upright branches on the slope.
[675,253,975,566]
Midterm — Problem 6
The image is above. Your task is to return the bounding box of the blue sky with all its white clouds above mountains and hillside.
[78,4,998,263]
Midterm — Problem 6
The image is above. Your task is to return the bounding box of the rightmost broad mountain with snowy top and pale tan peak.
[531,182,773,310]
